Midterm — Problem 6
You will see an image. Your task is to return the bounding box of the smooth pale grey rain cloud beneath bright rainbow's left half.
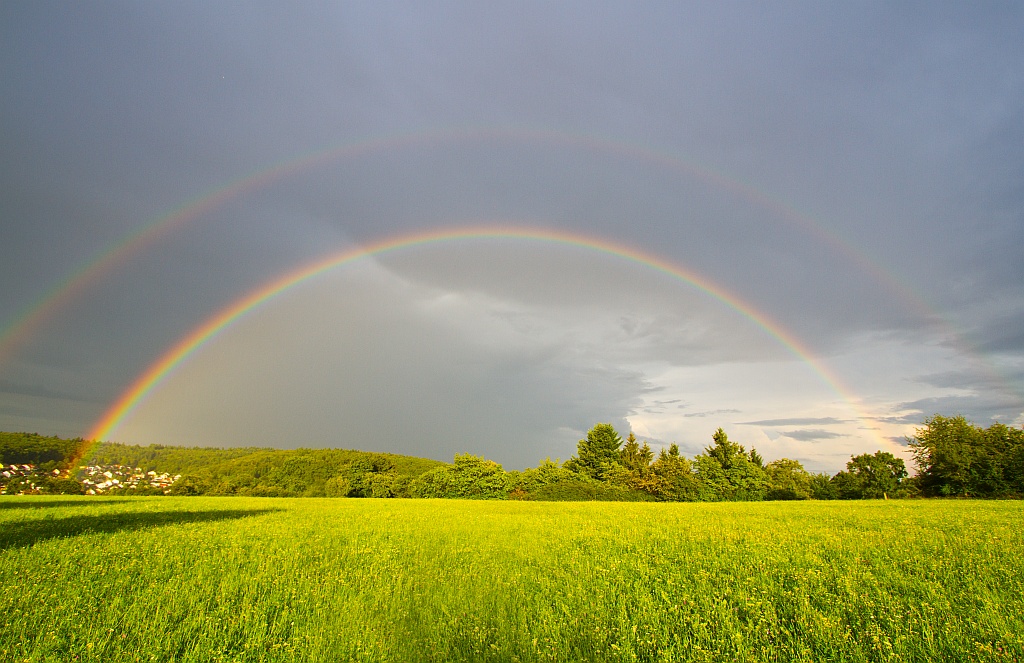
[108,262,647,467]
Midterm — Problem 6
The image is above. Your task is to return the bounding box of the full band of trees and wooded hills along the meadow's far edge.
[0,415,1024,501]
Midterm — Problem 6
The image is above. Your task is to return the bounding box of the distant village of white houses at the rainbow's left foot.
[0,464,181,495]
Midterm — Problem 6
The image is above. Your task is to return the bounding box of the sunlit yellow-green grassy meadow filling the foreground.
[0,497,1024,662]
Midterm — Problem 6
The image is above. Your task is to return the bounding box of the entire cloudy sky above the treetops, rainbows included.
[0,1,1024,473]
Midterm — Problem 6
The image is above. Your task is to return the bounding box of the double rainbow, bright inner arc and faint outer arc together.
[0,122,999,457]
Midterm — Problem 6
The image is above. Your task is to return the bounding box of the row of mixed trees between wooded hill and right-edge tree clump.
[410,423,918,502]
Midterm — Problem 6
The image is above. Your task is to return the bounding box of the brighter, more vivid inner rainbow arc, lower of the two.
[83,226,892,453]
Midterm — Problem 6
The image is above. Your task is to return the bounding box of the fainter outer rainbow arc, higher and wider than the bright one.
[0,128,936,362]
